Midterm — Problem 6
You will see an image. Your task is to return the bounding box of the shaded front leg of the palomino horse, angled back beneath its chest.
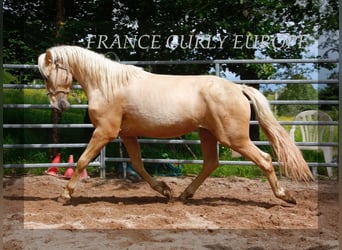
[121,136,172,199]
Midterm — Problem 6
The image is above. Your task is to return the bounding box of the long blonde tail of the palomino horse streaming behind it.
[240,85,314,181]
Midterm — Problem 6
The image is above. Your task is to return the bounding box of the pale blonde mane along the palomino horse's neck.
[45,46,145,100]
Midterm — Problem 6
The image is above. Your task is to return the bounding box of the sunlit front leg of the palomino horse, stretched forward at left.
[58,128,113,202]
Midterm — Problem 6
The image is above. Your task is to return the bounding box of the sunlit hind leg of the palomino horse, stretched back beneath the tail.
[230,139,296,204]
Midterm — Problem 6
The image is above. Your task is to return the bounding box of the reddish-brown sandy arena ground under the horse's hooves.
[3,176,339,250]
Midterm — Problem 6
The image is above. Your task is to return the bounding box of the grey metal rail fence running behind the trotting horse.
[3,59,339,177]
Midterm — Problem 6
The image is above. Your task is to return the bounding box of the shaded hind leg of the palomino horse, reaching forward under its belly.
[179,129,218,201]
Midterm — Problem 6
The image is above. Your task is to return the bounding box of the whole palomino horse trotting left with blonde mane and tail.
[38,46,313,204]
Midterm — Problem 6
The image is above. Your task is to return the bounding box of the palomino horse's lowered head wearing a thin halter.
[38,50,72,111]
